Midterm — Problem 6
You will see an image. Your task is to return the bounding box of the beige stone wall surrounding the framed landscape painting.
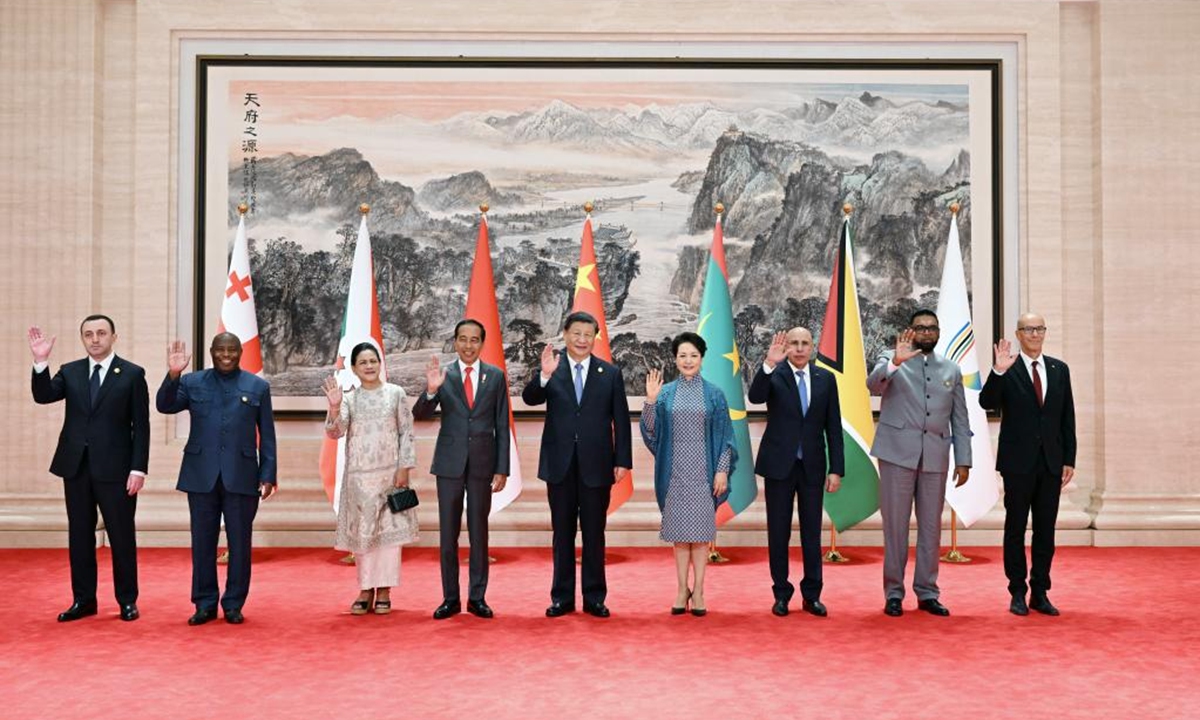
[0,0,1200,545]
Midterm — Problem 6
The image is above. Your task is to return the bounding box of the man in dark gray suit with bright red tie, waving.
[413,318,510,620]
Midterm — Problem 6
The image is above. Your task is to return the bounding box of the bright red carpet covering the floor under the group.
[0,547,1200,720]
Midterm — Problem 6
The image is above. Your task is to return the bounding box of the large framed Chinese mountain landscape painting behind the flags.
[200,62,996,405]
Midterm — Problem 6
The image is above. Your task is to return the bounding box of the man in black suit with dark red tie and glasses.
[979,313,1075,616]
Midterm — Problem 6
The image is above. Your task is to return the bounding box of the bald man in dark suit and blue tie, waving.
[748,328,846,617]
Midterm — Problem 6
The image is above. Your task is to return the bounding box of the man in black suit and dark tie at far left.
[29,314,150,623]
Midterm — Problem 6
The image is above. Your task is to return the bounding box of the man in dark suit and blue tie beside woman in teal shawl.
[521,312,634,618]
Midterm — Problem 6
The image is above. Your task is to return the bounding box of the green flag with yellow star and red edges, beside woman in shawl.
[696,214,758,526]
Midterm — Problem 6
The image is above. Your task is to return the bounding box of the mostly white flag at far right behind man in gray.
[934,214,1000,527]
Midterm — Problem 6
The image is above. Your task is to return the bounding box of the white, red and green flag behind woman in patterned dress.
[319,211,388,512]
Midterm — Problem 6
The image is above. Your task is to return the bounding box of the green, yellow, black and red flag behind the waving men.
[817,215,880,532]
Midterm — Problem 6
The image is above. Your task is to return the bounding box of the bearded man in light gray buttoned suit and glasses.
[866,310,971,617]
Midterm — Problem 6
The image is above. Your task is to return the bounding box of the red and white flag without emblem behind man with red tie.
[466,215,521,515]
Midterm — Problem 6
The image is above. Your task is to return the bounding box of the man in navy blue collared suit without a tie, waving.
[155,332,276,625]
